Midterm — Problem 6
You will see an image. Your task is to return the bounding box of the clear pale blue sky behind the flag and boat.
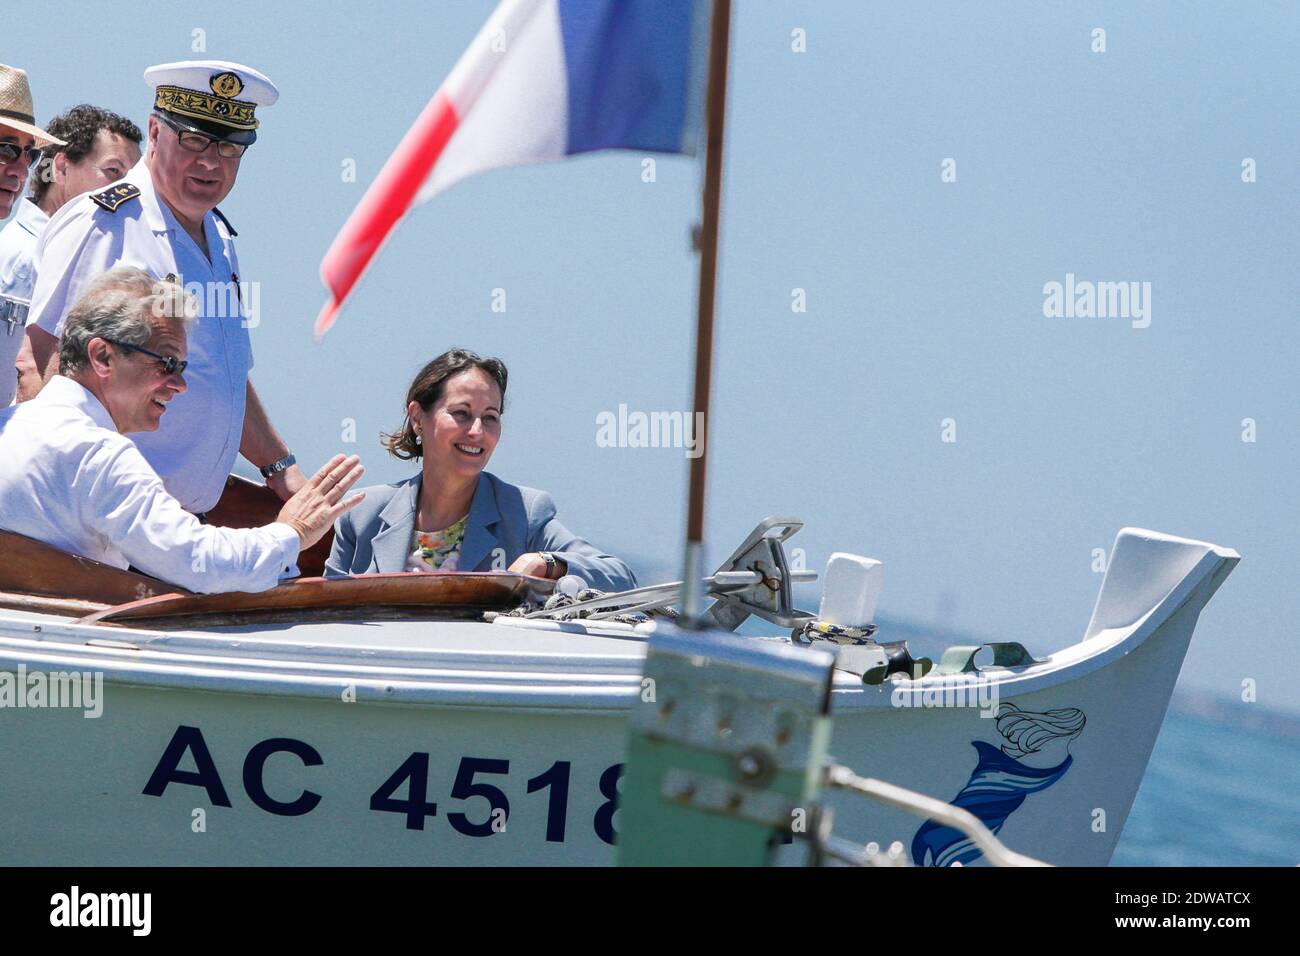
[10,0,1300,709]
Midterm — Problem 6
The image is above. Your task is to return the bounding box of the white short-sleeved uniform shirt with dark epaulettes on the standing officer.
[27,160,252,512]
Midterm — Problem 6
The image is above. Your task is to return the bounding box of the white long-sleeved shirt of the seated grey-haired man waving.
[0,375,299,592]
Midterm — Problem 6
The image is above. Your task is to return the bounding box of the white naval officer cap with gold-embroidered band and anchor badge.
[144,60,280,146]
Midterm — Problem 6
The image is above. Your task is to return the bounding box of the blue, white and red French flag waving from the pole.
[316,0,712,338]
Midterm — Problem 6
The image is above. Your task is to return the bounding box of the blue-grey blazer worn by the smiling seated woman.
[325,471,637,591]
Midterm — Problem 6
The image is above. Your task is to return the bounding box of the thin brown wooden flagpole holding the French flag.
[681,0,731,628]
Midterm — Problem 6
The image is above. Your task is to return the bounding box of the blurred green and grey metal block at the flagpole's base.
[618,626,835,866]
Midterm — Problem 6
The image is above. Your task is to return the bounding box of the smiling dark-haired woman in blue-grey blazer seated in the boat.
[325,349,637,591]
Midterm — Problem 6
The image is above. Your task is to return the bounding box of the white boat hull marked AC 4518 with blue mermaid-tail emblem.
[0,528,1236,865]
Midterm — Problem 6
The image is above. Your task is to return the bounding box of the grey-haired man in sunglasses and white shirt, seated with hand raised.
[0,267,364,593]
